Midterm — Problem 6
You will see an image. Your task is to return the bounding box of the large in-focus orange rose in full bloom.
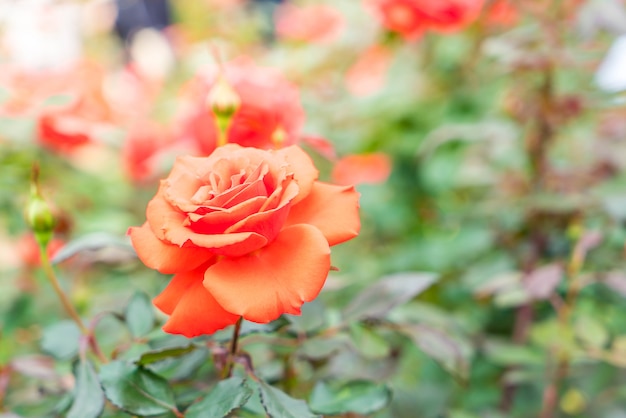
[129,144,360,337]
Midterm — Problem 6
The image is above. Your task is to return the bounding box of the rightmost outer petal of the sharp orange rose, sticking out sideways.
[285,181,361,246]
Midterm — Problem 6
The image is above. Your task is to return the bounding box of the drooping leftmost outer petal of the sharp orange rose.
[128,222,215,274]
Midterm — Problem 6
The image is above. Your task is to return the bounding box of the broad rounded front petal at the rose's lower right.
[204,225,330,323]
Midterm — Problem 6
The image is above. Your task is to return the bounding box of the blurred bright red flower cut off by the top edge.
[370,0,484,40]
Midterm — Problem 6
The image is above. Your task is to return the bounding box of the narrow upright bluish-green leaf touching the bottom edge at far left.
[67,359,104,418]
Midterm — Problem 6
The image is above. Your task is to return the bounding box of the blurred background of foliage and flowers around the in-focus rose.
[0,0,626,418]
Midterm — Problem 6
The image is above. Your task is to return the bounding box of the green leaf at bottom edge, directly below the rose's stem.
[185,377,252,418]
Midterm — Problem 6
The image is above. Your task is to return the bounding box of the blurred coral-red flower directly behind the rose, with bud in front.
[180,59,304,155]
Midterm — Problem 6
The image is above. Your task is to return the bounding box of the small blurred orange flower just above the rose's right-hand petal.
[332,152,391,184]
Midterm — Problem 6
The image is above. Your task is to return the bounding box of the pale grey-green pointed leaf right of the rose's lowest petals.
[344,272,438,320]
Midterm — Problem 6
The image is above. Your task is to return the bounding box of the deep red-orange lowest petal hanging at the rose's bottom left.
[154,267,239,338]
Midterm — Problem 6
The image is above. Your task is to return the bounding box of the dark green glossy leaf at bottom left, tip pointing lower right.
[100,361,177,416]
